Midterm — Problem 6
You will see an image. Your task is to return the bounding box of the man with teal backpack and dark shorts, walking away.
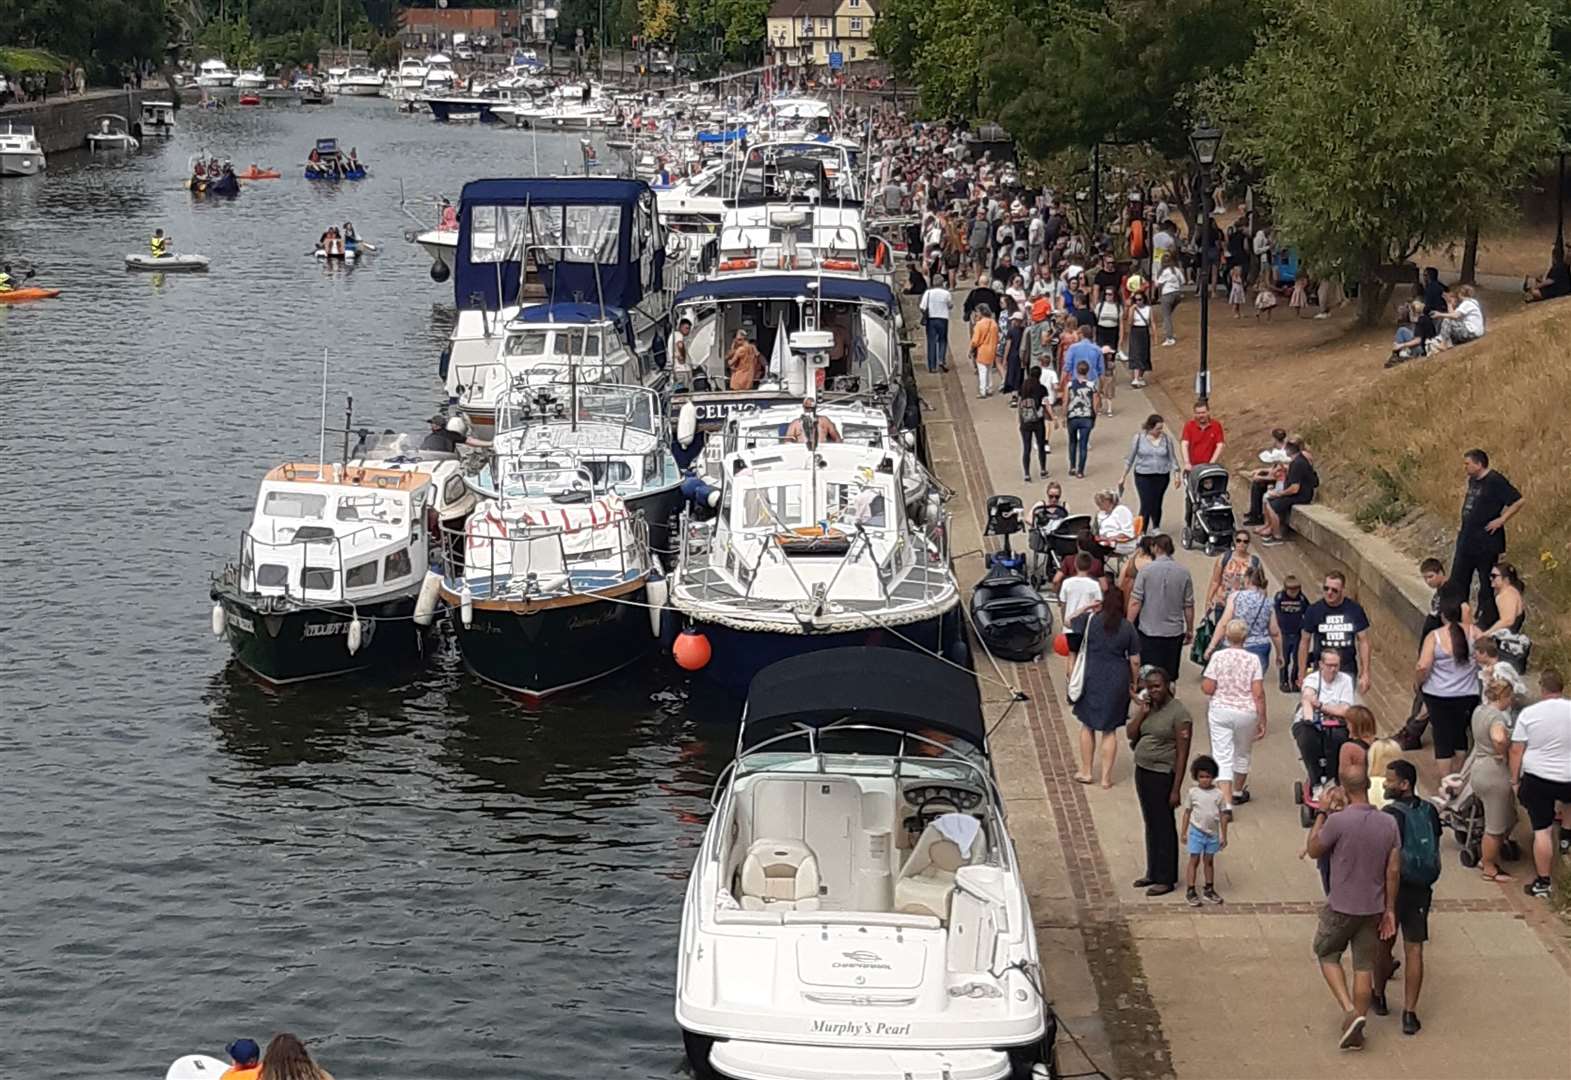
[1370,758,1441,1034]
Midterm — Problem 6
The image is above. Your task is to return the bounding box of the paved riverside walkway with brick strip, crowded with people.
[911,305,1571,1078]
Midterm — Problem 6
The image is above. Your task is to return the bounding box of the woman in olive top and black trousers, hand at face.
[1131,672,1194,896]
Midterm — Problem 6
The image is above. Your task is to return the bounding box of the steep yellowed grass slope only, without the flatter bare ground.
[1310,302,1571,671]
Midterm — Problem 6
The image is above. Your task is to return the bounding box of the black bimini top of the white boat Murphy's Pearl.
[742,648,987,750]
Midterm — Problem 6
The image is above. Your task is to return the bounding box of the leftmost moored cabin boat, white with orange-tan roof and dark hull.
[211,437,474,684]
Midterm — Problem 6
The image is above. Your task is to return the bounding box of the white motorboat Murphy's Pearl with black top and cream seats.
[676,648,1057,1080]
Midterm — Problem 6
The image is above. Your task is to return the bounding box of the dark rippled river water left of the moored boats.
[0,99,734,1077]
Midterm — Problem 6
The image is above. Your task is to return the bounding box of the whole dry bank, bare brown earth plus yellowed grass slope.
[1155,292,1571,671]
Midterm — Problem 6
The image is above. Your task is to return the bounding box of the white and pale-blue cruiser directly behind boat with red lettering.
[468,380,685,557]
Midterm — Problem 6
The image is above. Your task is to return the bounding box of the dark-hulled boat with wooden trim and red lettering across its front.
[440,459,663,706]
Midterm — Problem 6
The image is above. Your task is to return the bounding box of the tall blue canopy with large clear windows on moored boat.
[452,176,666,318]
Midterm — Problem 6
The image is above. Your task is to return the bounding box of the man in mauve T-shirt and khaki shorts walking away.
[1309,766,1401,1050]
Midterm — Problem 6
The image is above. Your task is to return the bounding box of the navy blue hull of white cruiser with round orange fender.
[693,607,971,698]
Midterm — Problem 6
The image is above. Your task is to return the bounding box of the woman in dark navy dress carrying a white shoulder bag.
[1075,590,1143,789]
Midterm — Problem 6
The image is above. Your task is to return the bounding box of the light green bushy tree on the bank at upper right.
[1207,0,1563,325]
